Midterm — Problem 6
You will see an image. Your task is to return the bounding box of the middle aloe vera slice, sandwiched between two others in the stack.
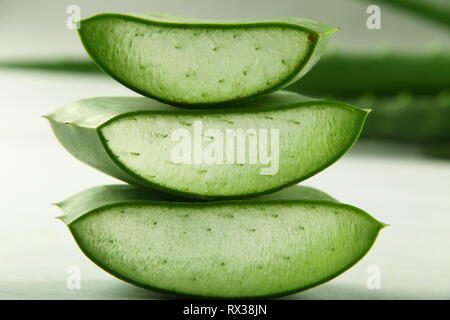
[47,92,367,198]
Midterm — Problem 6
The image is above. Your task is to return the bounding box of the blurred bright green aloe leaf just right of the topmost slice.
[286,50,450,98]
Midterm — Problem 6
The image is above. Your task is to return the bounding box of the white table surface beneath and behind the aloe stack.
[0,70,450,299]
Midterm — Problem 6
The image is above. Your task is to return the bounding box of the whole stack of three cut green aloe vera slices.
[47,14,384,298]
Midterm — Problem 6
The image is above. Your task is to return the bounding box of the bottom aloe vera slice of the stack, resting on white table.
[58,185,384,298]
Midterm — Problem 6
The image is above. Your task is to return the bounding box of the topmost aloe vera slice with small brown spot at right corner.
[79,14,336,107]
